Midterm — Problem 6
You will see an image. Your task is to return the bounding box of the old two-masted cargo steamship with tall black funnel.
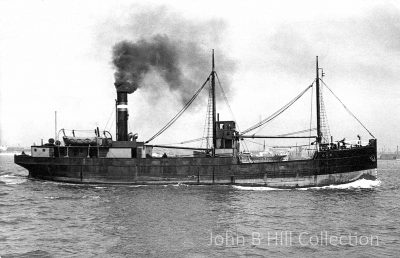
[14,52,377,188]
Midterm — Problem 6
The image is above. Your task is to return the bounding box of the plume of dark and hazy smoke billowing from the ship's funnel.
[112,8,234,102]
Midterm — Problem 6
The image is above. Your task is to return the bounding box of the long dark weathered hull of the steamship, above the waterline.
[14,141,377,188]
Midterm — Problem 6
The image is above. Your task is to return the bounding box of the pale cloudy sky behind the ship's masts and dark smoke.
[0,0,400,151]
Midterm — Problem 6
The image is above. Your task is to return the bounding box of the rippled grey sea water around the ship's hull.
[0,155,400,257]
